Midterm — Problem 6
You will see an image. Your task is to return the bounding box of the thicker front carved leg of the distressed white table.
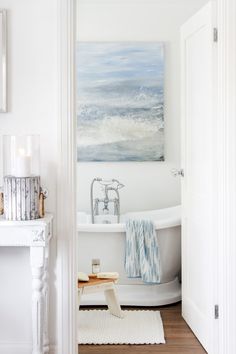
[30,247,44,354]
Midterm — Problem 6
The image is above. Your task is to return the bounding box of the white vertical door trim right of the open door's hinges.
[217,0,236,354]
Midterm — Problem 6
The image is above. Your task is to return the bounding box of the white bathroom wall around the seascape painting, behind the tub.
[77,0,206,212]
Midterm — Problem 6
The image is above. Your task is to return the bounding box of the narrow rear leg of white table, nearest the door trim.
[43,246,49,354]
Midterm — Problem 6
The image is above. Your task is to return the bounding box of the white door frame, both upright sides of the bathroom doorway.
[56,0,236,354]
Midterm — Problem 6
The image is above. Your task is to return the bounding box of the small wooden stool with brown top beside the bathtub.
[78,277,123,318]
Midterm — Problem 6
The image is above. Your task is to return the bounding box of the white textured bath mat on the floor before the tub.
[78,310,165,344]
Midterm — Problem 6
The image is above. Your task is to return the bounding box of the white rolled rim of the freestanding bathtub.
[77,205,181,233]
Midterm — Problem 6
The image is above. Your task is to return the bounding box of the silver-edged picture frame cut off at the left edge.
[0,10,7,113]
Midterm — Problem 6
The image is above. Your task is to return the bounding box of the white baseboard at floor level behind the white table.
[0,342,57,354]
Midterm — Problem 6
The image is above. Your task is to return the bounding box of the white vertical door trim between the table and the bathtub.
[57,0,78,354]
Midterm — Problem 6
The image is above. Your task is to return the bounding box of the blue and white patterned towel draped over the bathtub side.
[125,219,160,284]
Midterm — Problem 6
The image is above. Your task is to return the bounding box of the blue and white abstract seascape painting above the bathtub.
[77,42,164,161]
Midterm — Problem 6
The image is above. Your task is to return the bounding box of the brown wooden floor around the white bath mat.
[79,303,206,354]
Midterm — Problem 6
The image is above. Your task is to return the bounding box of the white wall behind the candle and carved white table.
[0,0,57,354]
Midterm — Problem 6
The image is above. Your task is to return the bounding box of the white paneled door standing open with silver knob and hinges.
[181,3,217,353]
